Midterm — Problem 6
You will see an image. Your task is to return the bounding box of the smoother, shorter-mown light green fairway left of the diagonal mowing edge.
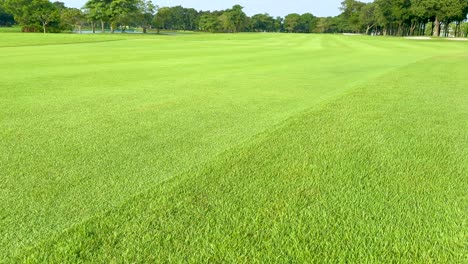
[0,34,463,258]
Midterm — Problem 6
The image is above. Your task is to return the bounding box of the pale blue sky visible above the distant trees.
[59,0,370,17]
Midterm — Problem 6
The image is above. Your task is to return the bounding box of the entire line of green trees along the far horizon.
[0,0,468,36]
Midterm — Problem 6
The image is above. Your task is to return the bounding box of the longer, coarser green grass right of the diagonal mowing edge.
[15,53,468,263]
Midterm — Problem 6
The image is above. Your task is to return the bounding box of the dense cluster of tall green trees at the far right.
[339,0,468,36]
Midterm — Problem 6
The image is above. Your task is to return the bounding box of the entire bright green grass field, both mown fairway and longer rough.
[0,34,468,263]
